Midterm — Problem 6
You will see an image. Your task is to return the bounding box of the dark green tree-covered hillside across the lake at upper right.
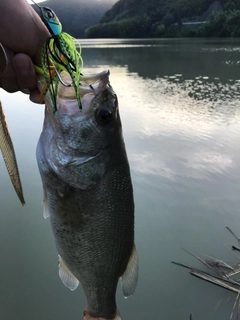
[86,0,240,38]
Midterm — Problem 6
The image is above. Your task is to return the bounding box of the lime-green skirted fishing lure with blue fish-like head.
[32,0,83,113]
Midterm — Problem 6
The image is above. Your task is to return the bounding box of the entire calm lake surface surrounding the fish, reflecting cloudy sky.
[0,39,240,320]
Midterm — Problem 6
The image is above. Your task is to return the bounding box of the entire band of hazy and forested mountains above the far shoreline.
[32,0,240,38]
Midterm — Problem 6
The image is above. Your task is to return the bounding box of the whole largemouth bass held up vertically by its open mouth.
[37,71,138,320]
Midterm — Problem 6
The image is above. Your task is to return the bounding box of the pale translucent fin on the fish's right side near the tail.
[121,245,138,298]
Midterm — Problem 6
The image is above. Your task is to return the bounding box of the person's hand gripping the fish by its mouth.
[0,0,49,102]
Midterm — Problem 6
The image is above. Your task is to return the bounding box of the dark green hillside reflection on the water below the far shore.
[83,41,240,83]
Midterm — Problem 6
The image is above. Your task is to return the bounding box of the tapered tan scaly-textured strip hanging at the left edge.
[0,101,25,205]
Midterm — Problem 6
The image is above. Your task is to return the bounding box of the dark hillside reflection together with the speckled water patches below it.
[83,40,240,117]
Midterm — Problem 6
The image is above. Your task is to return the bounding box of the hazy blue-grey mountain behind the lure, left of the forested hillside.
[33,0,117,38]
